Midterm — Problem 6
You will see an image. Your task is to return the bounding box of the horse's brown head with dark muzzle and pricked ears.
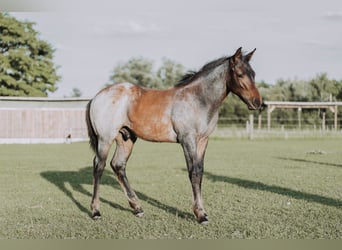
[227,48,262,110]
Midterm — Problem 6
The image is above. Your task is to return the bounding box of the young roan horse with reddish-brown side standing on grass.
[86,47,263,224]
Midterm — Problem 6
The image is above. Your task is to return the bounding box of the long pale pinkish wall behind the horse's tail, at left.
[0,97,88,143]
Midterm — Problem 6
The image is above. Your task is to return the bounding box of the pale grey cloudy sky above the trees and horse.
[0,0,342,97]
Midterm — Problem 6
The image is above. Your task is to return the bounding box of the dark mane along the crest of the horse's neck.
[175,57,229,87]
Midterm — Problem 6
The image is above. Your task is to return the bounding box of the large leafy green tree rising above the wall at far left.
[0,13,60,96]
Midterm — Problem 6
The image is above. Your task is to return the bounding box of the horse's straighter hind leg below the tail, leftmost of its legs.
[90,142,112,219]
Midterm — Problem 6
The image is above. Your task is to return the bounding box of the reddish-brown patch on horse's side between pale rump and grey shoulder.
[128,89,177,142]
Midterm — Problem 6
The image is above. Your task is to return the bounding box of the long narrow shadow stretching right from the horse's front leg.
[205,172,342,208]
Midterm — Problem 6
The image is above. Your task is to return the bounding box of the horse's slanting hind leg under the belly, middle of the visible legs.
[111,131,144,217]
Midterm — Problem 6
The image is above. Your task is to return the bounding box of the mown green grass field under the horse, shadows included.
[0,138,342,239]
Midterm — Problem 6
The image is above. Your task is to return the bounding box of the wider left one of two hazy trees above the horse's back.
[110,57,161,88]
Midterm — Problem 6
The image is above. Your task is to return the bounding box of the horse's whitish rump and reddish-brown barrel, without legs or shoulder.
[90,83,177,142]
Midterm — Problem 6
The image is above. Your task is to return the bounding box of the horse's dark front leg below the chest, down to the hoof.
[182,137,208,224]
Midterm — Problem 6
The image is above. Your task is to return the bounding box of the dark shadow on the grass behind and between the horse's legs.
[40,167,194,219]
